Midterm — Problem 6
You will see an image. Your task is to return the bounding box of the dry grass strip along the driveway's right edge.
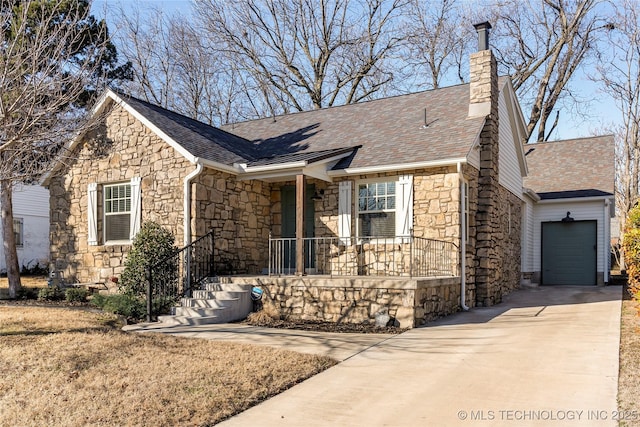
[618,300,640,427]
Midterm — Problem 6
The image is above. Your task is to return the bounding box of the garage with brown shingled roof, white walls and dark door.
[521,135,615,286]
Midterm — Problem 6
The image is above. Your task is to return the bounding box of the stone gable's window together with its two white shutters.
[87,177,141,246]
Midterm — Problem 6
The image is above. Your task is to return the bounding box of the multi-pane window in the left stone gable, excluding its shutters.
[103,184,131,242]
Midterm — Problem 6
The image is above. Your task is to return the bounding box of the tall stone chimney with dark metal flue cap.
[469,22,504,306]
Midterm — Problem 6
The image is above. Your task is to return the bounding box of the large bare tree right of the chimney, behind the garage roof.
[492,0,613,141]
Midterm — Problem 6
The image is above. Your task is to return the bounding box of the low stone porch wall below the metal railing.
[238,276,460,328]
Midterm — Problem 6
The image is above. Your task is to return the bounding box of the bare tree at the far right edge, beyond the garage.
[597,0,640,252]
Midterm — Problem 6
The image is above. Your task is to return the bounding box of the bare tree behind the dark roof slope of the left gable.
[115,6,253,125]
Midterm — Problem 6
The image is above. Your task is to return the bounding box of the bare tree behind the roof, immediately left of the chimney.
[405,0,475,89]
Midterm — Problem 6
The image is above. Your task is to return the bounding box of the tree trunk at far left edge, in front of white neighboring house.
[0,180,21,299]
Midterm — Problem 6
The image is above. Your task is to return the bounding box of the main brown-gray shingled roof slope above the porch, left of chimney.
[222,84,484,169]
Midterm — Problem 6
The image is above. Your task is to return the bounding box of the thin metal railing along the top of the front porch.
[269,235,459,277]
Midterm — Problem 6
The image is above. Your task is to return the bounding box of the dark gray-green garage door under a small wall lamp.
[542,221,597,285]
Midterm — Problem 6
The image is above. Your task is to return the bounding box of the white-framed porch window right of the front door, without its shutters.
[358,181,396,237]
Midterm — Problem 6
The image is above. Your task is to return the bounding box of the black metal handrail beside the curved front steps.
[146,230,216,322]
